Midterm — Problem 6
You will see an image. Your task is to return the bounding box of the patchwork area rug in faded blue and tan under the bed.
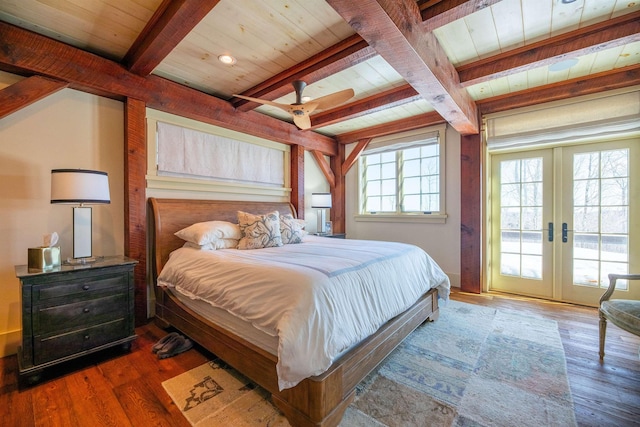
[162,301,576,427]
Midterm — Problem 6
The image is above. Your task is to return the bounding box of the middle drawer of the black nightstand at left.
[33,293,129,335]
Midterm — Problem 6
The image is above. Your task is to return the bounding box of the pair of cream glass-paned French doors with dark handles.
[489,140,640,306]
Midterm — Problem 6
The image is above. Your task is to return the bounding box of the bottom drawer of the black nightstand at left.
[33,318,130,365]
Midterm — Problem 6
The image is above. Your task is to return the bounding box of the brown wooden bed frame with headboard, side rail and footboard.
[149,198,438,427]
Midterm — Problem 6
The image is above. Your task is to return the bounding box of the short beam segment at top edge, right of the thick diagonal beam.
[418,0,502,31]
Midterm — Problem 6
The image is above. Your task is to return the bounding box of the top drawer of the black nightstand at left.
[32,273,128,304]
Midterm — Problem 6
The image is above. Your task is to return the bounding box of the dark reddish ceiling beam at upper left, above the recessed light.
[123,0,220,76]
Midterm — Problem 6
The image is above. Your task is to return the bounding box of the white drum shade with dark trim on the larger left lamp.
[51,169,111,204]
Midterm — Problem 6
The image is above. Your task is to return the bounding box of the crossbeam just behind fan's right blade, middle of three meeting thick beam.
[311,85,420,129]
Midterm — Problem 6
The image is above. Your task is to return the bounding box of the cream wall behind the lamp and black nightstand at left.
[0,72,124,357]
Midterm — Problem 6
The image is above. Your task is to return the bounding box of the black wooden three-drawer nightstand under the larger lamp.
[15,256,138,383]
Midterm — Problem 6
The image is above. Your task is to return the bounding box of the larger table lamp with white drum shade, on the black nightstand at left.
[51,169,111,264]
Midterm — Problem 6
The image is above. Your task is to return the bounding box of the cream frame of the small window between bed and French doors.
[355,125,447,223]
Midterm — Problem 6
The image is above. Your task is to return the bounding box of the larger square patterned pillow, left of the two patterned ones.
[238,211,282,249]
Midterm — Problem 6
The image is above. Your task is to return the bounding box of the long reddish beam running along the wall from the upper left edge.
[0,22,337,156]
